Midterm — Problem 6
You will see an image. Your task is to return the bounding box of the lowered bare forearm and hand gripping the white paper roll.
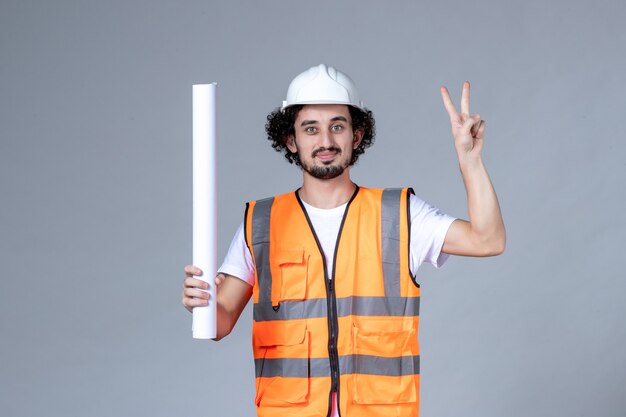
[182,265,252,341]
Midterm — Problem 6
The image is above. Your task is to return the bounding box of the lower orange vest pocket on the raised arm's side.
[352,322,419,404]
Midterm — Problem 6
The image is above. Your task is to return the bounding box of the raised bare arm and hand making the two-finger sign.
[441,82,506,256]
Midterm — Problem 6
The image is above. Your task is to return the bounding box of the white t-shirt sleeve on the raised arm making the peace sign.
[410,195,456,275]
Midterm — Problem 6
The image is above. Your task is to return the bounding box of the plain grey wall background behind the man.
[0,0,626,417]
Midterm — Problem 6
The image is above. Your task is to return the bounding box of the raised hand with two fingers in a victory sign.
[441,81,485,158]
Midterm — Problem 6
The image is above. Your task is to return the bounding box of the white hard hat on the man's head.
[282,64,363,110]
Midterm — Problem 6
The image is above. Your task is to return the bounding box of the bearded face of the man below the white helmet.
[287,104,363,179]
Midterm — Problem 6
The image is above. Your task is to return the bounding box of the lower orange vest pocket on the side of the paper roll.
[254,321,309,407]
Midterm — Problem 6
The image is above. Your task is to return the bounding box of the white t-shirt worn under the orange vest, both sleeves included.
[219,195,455,285]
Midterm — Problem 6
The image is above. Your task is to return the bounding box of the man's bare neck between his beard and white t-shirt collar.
[298,169,356,209]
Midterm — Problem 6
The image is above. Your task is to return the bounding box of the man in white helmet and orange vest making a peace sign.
[183,65,505,417]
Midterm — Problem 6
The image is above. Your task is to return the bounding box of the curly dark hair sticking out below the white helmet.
[265,105,376,166]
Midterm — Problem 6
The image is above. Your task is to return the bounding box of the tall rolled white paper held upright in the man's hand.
[192,83,217,339]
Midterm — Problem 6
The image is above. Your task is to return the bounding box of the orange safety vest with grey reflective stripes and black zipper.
[245,187,420,417]
